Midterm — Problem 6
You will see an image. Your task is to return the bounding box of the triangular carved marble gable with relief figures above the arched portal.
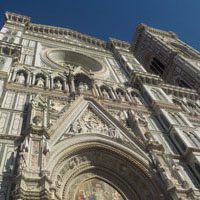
[49,96,144,155]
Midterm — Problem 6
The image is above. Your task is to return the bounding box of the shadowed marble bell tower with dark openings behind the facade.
[131,24,200,90]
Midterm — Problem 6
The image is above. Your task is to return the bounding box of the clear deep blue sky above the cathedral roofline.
[0,0,200,50]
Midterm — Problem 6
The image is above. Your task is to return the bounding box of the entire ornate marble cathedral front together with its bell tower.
[0,12,200,200]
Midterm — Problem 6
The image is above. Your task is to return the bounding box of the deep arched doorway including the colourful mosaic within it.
[49,136,164,200]
